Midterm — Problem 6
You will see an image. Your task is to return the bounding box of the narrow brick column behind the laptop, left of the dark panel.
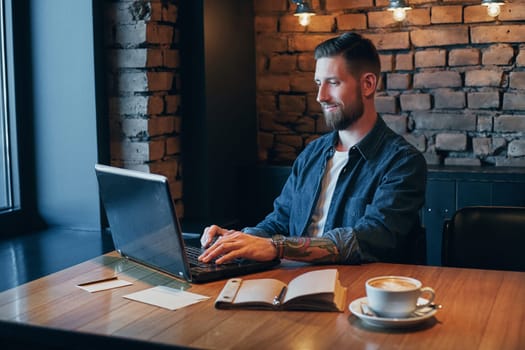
[105,0,184,216]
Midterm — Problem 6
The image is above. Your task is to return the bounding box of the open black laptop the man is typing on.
[95,164,280,283]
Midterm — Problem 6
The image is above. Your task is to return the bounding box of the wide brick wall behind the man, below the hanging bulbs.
[254,0,525,167]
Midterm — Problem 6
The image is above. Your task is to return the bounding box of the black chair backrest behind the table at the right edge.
[442,206,525,271]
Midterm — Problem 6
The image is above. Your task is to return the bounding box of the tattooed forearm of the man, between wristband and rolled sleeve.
[284,237,339,263]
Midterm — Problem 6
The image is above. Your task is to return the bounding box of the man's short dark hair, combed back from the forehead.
[314,33,381,78]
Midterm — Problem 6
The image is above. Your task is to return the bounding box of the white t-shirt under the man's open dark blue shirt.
[308,151,348,237]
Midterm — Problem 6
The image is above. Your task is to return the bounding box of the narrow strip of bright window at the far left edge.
[0,0,20,214]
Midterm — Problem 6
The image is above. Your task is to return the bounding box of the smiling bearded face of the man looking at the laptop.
[315,56,364,130]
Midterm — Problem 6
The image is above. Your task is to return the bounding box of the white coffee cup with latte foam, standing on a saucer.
[365,276,435,318]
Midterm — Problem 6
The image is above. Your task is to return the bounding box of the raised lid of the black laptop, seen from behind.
[95,164,191,280]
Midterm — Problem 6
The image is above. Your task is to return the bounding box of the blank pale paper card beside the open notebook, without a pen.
[124,286,210,310]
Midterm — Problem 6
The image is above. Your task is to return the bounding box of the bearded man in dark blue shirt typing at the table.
[200,33,426,264]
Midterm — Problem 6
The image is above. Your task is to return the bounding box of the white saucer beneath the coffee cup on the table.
[348,297,437,328]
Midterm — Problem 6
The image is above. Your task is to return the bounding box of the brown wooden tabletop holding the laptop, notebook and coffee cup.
[0,253,525,349]
